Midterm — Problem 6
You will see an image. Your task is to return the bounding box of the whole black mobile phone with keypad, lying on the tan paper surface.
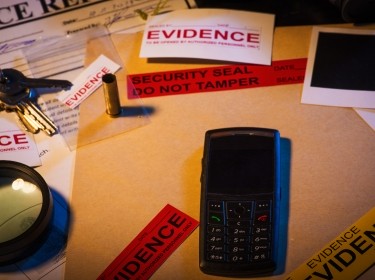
[199,127,281,277]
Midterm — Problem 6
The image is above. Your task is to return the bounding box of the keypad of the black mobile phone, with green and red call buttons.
[206,200,272,263]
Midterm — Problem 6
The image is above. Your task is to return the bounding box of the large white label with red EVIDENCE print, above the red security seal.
[140,9,274,65]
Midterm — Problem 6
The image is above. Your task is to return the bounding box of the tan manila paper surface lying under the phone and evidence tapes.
[65,26,375,279]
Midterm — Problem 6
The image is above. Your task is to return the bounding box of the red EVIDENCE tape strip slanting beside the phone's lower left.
[97,204,199,280]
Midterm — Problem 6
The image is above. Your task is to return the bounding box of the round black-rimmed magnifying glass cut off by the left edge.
[0,160,53,265]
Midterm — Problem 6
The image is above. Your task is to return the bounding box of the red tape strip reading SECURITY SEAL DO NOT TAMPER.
[128,58,307,99]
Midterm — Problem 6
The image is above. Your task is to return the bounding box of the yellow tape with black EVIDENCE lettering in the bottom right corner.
[286,208,375,280]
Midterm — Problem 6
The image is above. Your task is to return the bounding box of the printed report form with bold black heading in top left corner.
[0,0,194,75]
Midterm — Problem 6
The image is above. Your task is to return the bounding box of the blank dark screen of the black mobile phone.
[207,134,274,195]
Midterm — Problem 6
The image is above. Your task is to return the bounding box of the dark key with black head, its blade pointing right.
[0,68,72,105]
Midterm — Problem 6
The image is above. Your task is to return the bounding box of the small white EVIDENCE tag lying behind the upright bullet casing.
[58,55,121,109]
